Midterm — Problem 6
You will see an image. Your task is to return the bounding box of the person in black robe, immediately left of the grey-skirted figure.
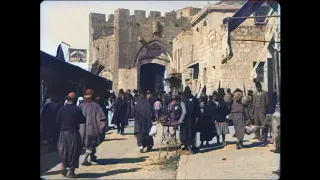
[197,98,217,147]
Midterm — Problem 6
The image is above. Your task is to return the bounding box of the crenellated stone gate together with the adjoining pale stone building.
[89,1,275,94]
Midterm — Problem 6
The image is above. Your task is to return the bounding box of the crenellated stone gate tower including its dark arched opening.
[89,7,200,91]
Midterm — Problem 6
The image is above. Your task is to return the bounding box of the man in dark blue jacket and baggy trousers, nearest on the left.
[57,92,86,178]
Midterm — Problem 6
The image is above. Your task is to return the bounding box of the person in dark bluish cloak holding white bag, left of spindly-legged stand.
[133,95,154,153]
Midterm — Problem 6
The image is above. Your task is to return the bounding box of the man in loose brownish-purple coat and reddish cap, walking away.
[79,89,107,166]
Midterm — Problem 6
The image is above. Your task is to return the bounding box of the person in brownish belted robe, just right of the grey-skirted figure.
[230,92,247,149]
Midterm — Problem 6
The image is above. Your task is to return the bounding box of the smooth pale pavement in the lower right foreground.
[177,127,280,179]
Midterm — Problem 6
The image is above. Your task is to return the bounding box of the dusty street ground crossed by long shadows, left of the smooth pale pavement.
[44,124,179,179]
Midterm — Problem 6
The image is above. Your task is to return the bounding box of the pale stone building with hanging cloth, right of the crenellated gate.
[173,3,275,94]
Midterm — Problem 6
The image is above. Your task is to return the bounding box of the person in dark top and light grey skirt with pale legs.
[212,91,230,146]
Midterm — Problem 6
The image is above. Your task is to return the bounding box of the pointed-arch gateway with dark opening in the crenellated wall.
[134,40,172,92]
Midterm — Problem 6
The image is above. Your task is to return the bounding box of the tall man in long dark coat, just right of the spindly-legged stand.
[179,86,200,153]
